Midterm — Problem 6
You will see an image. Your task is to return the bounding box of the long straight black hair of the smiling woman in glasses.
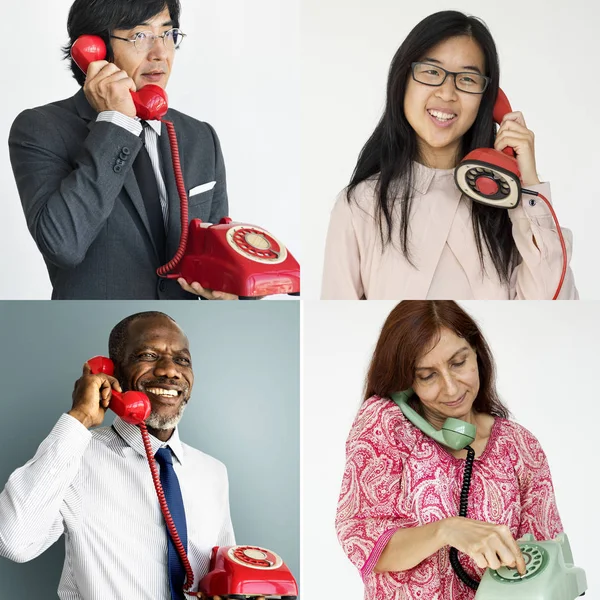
[346,10,517,282]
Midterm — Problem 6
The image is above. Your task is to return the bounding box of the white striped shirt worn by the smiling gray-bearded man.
[0,414,235,600]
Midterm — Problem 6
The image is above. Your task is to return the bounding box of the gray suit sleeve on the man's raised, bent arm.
[8,107,142,268]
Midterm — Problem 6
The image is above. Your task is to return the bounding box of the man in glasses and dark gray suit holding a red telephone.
[9,0,236,299]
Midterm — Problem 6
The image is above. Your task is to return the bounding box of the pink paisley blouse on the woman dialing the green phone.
[336,396,563,600]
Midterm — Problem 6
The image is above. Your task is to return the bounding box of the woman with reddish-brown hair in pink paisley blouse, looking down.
[336,301,563,600]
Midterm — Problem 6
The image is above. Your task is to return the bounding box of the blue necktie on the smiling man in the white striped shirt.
[155,448,187,600]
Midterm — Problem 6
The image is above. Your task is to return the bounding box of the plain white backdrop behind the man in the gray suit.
[0,0,301,299]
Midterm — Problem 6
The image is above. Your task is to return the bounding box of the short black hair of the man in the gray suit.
[62,0,181,85]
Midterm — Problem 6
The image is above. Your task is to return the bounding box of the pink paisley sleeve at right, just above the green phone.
[515,426,563,540]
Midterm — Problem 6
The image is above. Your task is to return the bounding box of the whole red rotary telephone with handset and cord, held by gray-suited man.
[71,35,300,298]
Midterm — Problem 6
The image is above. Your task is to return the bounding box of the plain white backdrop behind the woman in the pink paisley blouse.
[301,301,600,600]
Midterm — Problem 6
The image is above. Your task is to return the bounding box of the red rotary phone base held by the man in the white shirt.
[198,546,298,600]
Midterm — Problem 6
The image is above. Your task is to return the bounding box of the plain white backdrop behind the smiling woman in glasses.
[301,0,600,299]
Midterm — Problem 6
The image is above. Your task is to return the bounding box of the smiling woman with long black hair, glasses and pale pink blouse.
[322,11,578,299]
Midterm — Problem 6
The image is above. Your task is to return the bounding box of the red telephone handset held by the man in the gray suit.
[71,35,169,121]
